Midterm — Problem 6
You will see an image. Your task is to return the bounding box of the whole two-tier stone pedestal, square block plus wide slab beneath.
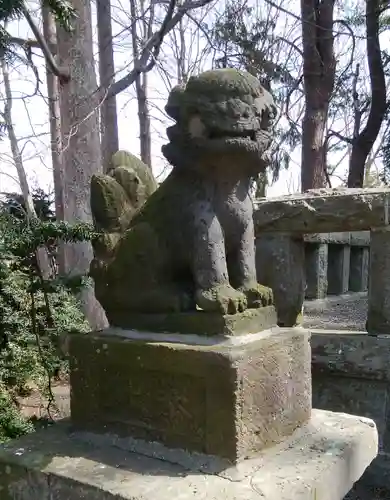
[0,312,378,500]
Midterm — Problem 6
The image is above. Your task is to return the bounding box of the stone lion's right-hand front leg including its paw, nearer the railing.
[228,217,273,307]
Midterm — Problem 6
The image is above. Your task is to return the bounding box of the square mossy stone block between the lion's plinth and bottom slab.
[69,327,311,463]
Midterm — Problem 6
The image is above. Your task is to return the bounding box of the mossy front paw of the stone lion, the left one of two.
[195,285,247,314]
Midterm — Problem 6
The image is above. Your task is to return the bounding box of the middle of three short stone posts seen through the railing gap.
[328,245,351,295]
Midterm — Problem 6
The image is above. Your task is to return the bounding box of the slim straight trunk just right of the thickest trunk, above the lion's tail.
[96,0,119,172]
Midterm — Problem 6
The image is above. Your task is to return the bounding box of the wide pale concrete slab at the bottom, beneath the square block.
[0,410,378,500]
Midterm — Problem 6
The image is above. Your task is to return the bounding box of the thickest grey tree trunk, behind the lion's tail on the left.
[57,0,107,329]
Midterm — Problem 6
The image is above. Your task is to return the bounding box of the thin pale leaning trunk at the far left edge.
[1,58,53,280]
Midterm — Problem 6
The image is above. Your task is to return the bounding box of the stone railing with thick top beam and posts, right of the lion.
[254,188,390,335]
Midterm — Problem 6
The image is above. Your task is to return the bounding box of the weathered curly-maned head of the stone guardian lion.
[162,69,276,174]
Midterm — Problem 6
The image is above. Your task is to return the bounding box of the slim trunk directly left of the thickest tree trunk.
[42,6,64,223]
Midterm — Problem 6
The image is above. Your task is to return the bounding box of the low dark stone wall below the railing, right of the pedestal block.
[311,331,390,490]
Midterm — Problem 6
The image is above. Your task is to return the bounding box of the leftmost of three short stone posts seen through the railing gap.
[305,243,328,299]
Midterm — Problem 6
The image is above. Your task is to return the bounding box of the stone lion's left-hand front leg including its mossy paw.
[192,206,247,314]
